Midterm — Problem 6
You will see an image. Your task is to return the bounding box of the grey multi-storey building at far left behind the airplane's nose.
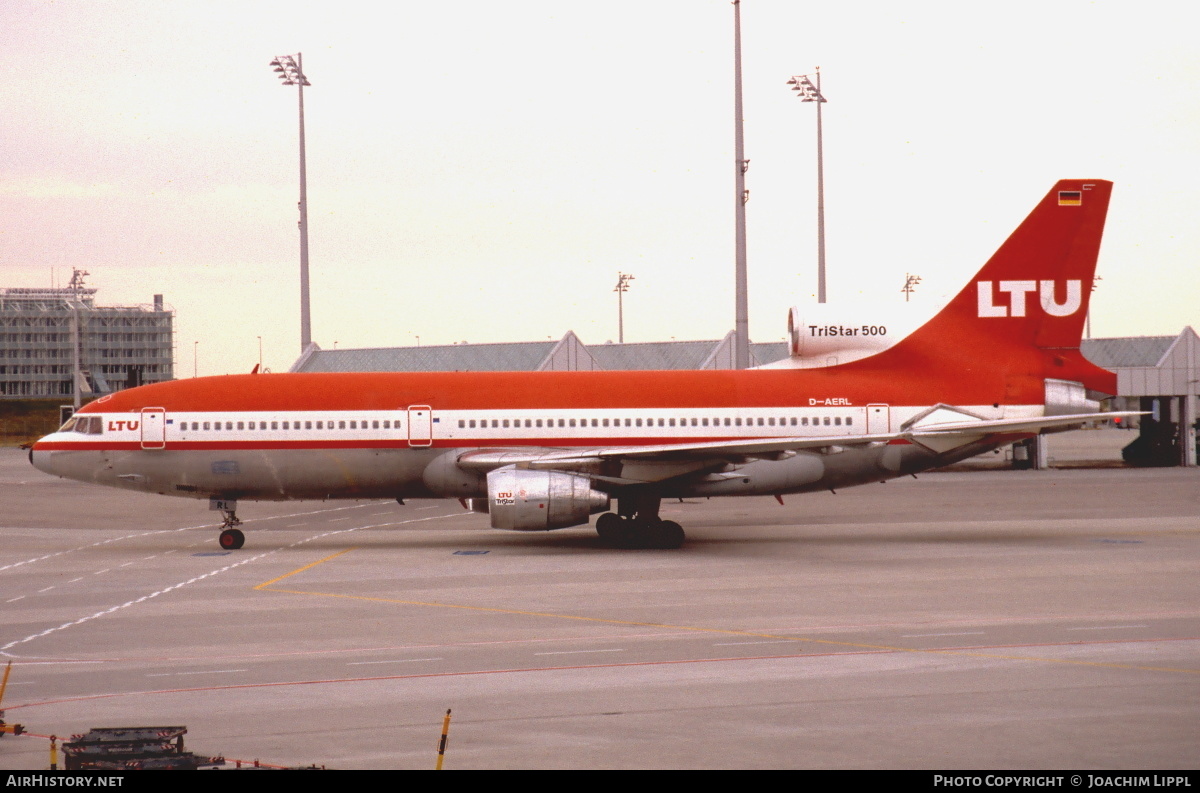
[0,278,175,399]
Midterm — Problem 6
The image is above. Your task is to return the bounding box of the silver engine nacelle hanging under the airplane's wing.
[487,465,608,531]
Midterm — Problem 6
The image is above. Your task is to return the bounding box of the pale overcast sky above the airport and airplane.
[0,0,1200,377]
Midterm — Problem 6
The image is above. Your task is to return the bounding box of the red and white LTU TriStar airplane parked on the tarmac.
[29,179,1134,551]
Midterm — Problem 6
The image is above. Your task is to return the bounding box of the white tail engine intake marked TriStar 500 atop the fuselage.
[787,304,919,366]
